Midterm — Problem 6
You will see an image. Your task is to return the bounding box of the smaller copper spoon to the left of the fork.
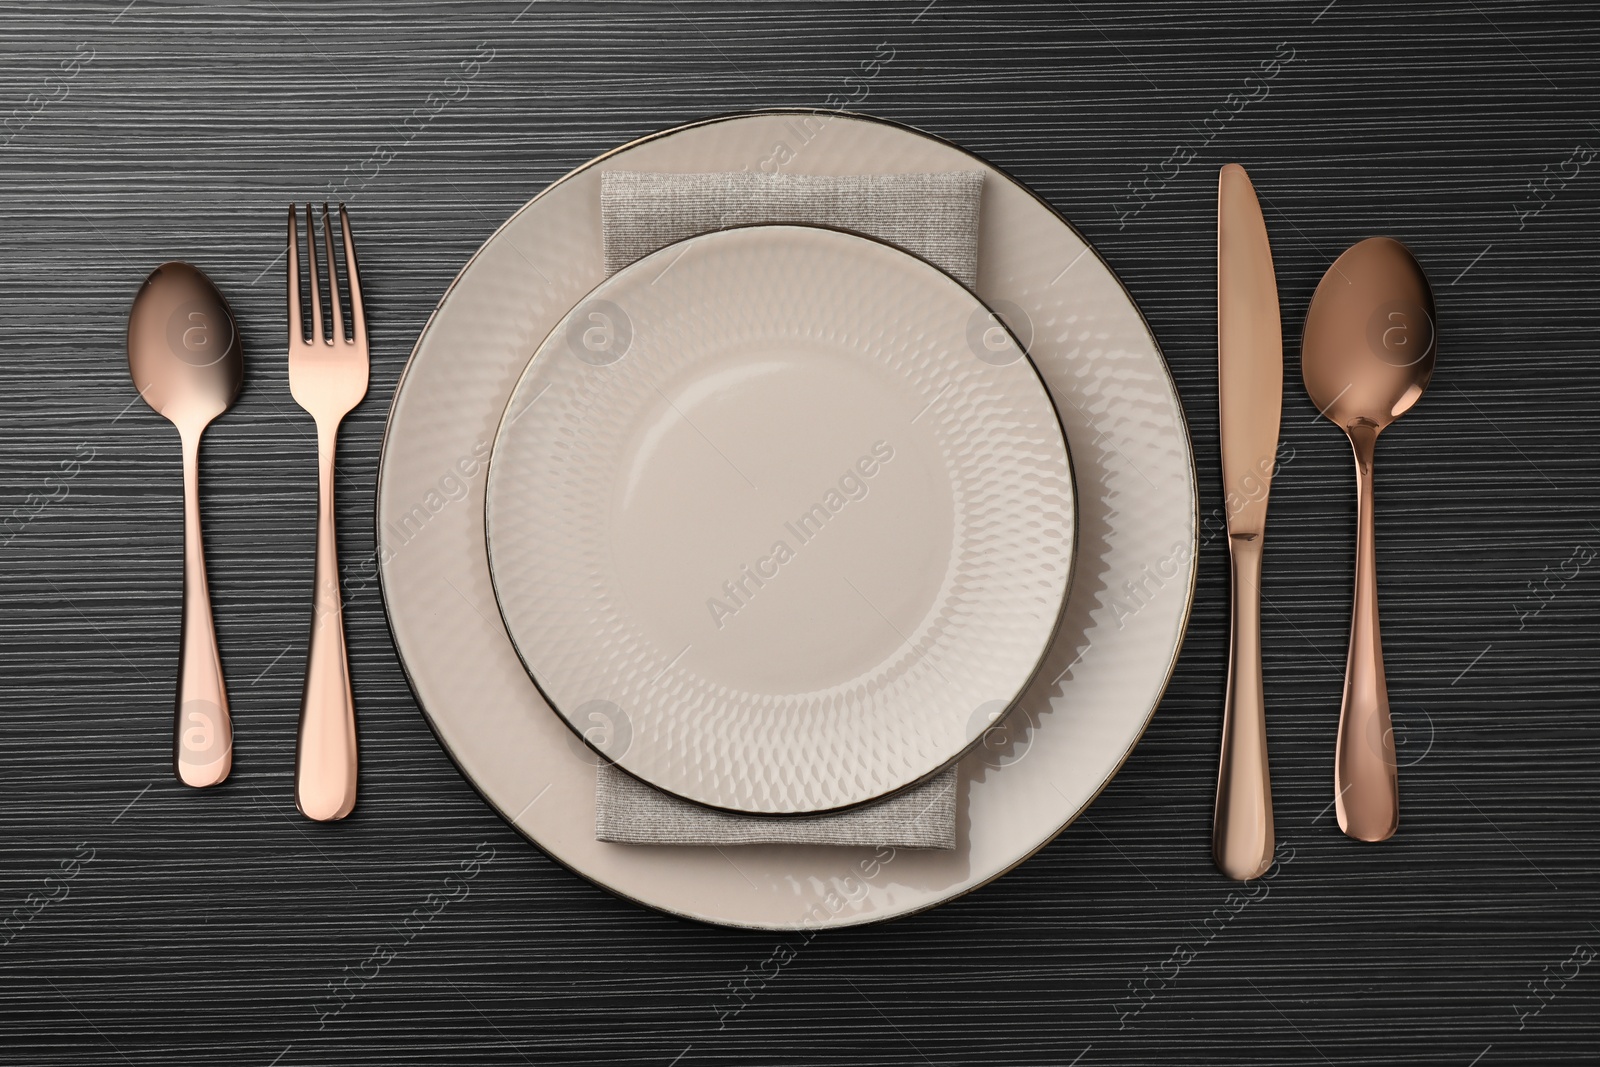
[128,262,245,787]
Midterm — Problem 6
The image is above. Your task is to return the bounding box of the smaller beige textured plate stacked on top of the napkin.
[488,226,1072,814]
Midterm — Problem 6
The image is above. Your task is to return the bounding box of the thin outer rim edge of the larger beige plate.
[373,107,1200,931]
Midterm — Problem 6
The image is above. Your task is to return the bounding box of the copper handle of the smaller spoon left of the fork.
[173,427,234,789]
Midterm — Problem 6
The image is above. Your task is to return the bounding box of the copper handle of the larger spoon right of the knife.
[1333,424,1400,841]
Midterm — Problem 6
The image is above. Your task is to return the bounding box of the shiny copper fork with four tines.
[288,203,368,822]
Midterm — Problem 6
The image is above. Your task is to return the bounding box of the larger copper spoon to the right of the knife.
[1301,237,1437,841]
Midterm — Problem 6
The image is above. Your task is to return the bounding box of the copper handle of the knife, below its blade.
[1211,534,1274,881]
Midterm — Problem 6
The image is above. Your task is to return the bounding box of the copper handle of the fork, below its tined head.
[294,421,357,822]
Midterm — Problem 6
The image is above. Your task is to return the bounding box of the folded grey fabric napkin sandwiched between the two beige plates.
[595,171,984,848]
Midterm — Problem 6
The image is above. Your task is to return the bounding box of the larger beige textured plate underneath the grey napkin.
[378,112,1198,929]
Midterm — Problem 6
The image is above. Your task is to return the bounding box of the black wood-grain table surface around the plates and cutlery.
[0,0,1600,1067]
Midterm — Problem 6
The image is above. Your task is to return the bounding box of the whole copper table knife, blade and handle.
[1211,163,1283,880]
